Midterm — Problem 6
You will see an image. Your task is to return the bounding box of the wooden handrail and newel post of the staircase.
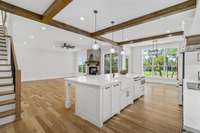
[4,35,21,120]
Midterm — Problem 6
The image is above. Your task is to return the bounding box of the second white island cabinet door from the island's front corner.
[112,84,120,115]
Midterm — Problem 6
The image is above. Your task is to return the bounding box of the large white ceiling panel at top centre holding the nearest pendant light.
[54,0,188,32]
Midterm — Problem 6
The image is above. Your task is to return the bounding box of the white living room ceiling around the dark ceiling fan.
[12,15,111,50]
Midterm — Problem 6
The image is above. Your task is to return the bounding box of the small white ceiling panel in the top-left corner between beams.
[2,0,54,14]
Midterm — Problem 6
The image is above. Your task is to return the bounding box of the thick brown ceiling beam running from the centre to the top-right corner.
[92,0,196,36]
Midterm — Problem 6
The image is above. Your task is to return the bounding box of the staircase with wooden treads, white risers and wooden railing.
[0,26,21,125]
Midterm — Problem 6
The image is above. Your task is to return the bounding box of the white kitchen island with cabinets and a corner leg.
[65,74,144,127]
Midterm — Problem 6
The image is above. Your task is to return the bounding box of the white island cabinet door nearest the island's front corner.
[103,86,112,121]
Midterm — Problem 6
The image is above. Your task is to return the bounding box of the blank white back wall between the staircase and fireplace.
[15,47,76,81]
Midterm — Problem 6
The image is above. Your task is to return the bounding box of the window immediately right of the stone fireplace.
[104,53,119,74]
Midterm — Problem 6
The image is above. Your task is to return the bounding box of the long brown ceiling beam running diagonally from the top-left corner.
[0,1,117,45]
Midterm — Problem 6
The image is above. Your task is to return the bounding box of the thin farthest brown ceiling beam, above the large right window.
[118,31,184,45]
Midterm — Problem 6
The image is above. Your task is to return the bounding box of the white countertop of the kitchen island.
[65,74,142,86]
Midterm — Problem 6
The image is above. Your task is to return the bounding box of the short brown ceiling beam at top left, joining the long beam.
[43,0,72,21]
